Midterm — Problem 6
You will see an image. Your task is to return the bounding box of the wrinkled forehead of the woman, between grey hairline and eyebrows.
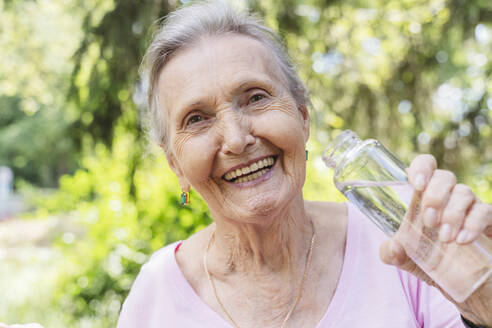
[157,34,287,111]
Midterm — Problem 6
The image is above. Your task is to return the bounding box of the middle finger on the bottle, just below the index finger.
[422,170,456,227]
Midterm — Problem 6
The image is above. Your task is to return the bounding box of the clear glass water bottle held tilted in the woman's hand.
[323,130,492,302]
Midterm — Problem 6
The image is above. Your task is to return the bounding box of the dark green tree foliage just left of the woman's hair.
[69,0,172,148]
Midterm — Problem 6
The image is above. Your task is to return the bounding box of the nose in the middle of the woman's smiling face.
[220,113,256,155]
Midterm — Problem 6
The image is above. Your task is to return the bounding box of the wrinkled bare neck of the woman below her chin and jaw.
[210,195,314,275]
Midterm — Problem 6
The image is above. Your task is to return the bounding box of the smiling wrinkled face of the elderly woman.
[157,34,309,223]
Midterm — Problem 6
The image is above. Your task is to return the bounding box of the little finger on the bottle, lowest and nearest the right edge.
[456,202,492,244]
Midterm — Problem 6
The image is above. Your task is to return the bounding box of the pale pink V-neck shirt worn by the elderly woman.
[117,204,465,328]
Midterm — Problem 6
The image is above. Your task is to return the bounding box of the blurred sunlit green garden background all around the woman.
[0,0,492,328]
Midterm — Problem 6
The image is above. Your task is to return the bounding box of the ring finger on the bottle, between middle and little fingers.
[438,184,475,242]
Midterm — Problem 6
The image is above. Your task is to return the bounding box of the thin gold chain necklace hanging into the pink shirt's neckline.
[203,221,316,328]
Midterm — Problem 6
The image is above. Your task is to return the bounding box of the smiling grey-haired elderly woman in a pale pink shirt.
[118,2,492,328]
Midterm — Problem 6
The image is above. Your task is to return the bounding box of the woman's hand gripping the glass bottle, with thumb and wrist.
[380,155,492,326]
